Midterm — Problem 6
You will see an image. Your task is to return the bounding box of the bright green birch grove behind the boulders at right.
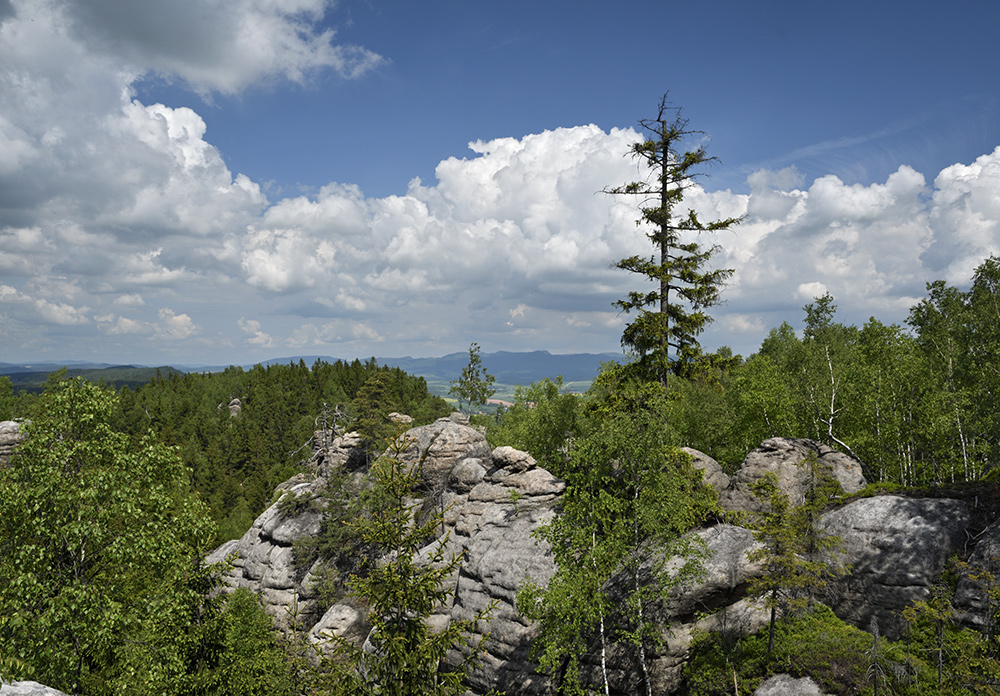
[670,258,1000,486]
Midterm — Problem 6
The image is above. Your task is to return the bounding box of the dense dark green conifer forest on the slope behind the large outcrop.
[109,359,450,543]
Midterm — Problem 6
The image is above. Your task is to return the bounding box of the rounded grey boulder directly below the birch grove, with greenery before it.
[719,437,867,512]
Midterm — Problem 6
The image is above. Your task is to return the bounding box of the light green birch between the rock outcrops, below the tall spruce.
[518,368,715,694]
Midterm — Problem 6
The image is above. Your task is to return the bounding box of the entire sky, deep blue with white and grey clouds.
[0,0,1000,365]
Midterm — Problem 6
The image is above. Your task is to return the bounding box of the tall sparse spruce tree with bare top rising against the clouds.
[605,95,740,386]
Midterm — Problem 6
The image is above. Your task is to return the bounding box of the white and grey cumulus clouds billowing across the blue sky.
[0,0,1000,364]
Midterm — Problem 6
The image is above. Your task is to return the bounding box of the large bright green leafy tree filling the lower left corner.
[0,380,214,693]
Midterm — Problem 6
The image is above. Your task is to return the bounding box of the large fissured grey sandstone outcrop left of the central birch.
[208,414,565,694]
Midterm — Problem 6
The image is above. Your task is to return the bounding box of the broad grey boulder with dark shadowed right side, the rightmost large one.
[821,496,970,639]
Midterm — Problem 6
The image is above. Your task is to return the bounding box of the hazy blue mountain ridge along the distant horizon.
[0,350,623,388]
